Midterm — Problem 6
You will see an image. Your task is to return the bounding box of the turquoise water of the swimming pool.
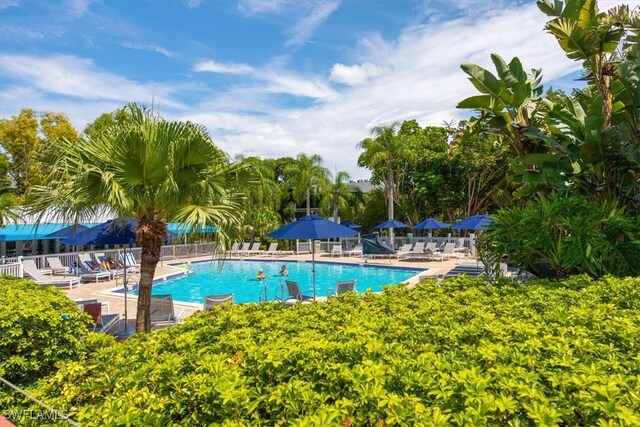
[138,261,422,303]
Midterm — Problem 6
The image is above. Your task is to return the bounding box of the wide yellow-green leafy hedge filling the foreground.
[6,276,640,426]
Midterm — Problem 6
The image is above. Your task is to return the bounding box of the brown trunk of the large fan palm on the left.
[136,218,167,332]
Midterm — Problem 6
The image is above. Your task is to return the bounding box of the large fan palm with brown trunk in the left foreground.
[28,104,252,332]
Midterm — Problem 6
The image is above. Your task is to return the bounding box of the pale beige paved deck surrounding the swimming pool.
[64,254,470,331]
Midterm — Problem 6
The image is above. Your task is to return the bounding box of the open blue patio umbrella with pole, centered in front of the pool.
[267,214,358,300]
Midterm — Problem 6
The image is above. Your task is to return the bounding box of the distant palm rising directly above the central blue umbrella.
[284,153,329,215]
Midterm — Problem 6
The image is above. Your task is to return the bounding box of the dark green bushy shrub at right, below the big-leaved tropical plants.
[481,193,640,279]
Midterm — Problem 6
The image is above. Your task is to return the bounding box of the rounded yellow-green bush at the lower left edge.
[0,276,91,383]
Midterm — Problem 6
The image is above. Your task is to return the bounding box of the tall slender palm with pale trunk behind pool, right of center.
[357,123,416,244]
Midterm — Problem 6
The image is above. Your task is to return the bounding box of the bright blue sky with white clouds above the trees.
[0,0,639,178]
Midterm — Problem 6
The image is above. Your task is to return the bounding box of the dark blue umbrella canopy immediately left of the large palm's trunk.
[62,219,138,245]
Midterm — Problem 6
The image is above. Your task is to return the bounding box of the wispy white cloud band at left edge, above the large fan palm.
[0,55,184,109]
